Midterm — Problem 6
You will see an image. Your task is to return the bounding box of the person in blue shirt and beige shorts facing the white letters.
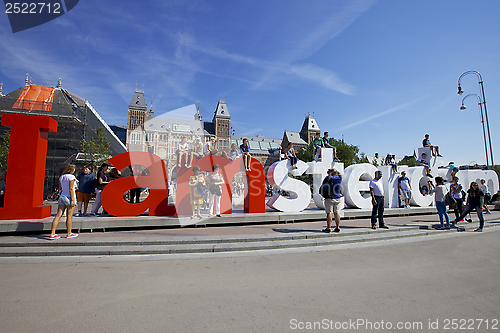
[322,168,342,233]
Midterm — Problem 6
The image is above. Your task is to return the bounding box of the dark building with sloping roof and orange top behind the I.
[0,75,127,194]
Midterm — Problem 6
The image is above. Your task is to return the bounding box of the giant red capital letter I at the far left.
[0,113,57,220]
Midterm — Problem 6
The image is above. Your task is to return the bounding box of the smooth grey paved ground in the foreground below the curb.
[0,216,500,333]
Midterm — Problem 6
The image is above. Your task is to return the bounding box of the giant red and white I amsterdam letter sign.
[0,114,499,220]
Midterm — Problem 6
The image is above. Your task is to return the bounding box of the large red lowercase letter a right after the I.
[101,151,175,216]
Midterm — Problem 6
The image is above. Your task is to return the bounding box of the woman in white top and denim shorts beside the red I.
[50,164,78,239]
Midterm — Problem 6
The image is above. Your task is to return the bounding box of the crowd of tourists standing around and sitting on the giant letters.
[42,132,500,239]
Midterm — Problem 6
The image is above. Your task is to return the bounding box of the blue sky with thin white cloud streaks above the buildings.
[0,0,500,164]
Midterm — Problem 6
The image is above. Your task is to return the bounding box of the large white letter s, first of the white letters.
[267,160,311,212]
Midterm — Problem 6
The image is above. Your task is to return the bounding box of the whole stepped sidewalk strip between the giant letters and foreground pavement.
[0,211,500,257]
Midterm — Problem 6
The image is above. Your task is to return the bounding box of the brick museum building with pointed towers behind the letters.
[126,89,320,179]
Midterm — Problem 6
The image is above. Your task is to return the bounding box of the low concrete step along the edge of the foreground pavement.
[0,223,492,257]
